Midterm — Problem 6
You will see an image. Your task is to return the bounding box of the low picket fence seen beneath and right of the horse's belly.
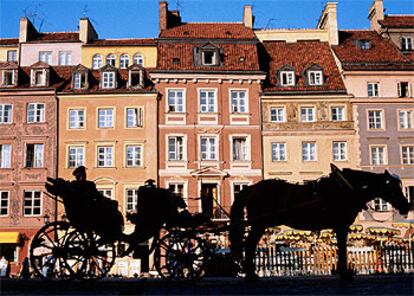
[256,244,414,276]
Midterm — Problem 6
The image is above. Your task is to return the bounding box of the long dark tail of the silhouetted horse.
[229,187,250,259]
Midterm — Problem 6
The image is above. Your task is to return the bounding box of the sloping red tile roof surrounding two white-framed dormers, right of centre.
[261,41,346,93]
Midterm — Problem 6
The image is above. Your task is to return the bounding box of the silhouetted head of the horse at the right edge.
[378,170,410,215]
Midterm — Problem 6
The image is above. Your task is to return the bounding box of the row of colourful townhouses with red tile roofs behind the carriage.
[0,0,414,270]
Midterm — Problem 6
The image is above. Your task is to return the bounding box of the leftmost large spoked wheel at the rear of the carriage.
[30,221,76,279]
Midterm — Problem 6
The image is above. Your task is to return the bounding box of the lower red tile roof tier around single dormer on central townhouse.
[157,42,260,72]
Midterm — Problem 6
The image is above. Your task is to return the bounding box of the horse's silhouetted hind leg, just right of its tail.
[244,225,266,281]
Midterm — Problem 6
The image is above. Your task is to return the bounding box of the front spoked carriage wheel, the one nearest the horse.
[154,232,208,281]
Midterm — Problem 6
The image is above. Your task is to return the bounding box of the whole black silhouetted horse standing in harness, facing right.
[229,165,410,281]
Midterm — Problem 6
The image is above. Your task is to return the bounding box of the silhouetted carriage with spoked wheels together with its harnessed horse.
[30,166,409,281]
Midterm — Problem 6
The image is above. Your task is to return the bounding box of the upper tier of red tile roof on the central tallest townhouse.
[159,23,256,39]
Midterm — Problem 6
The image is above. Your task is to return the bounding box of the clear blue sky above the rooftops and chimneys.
[0,0,414,38]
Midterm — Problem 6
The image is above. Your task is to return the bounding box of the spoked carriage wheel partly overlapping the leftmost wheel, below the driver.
[67,232,115,279]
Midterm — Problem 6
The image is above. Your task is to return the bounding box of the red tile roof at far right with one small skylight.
[332,30,414,71]
